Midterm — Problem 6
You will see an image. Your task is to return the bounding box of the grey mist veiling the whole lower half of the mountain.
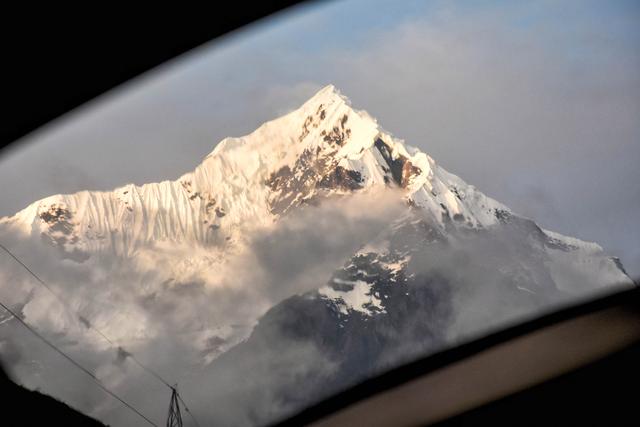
[0,189,632,425]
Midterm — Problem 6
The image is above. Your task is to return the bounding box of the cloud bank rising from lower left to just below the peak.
[0,190,403,425]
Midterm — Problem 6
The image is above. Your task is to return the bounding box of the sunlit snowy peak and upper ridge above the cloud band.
[0,85,628,287]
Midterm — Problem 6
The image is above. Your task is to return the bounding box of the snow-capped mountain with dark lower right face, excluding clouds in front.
[0,85,633,424]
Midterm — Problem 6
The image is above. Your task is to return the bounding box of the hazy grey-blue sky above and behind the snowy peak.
[0,0,640,277]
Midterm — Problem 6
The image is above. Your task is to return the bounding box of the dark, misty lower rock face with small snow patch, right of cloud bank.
[202,210,592,425]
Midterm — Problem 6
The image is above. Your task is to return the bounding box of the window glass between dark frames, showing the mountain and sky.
[0,0,640,425]
